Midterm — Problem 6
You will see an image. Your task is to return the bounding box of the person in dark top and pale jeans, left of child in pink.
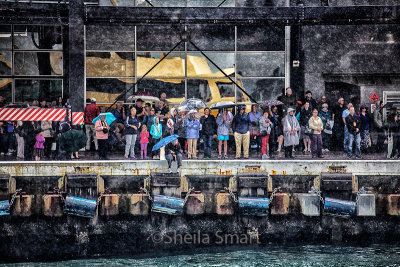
[125,108,140,160]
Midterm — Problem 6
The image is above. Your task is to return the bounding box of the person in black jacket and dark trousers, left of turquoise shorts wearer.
[200,108,217,159]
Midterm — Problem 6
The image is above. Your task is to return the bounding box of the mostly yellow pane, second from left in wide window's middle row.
[136,52,185,77]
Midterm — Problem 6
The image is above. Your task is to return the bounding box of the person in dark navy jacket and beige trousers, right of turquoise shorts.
[232,105,251,159]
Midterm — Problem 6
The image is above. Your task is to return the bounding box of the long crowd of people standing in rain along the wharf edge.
[0,88,400,163]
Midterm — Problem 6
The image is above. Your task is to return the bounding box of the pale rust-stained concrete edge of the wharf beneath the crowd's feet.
[0,160,400,176]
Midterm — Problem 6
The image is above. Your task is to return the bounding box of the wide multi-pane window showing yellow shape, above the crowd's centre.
[86,24,286,104]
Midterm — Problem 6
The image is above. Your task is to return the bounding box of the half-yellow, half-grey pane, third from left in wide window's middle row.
[187,52,235,77]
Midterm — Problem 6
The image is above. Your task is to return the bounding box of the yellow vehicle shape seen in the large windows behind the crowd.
[86,52,250,111]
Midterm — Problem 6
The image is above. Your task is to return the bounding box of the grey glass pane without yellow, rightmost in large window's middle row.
[236,52,285,77]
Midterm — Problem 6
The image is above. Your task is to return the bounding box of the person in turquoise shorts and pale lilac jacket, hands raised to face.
[216,108,233,159]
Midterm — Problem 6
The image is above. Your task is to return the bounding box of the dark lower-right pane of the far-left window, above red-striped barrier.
[15,79,62,102]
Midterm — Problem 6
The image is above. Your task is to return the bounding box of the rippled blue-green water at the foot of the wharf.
[6,245,400,267]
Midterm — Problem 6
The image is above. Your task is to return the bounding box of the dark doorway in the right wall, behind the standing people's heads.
[325,82,361,108]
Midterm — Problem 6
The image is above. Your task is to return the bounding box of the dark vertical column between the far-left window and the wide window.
[68,0,85,111]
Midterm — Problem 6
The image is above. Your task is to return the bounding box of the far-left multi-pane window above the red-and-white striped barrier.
[0,25,64,103]
